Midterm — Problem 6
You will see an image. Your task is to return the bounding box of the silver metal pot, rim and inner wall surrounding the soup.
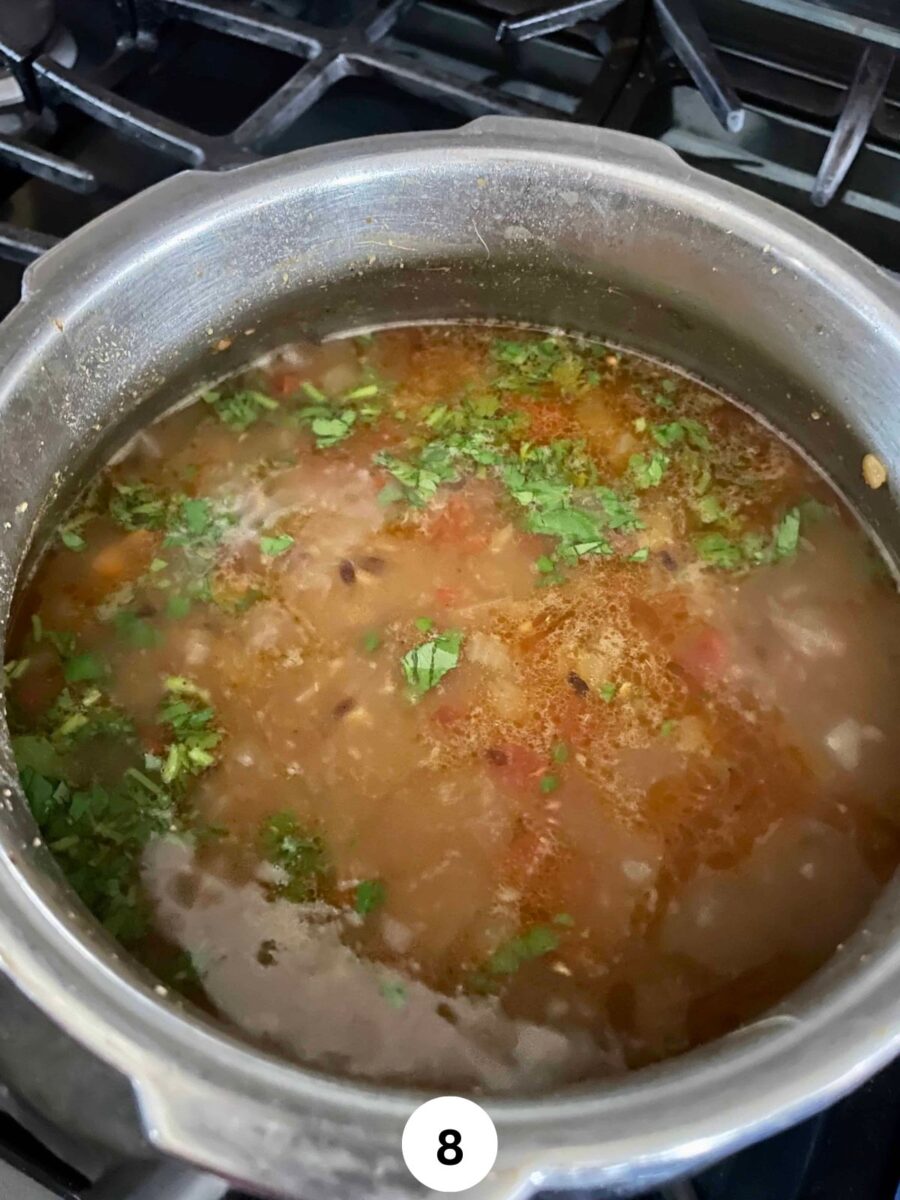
[0,119,900,1200]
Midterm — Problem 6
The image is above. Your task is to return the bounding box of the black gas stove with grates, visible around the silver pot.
[0,0,900,1200]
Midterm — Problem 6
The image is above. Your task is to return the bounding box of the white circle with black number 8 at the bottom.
[401,1096,497,1192]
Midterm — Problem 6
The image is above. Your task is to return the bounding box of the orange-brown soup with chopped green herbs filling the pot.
[6,326,900,1091]
